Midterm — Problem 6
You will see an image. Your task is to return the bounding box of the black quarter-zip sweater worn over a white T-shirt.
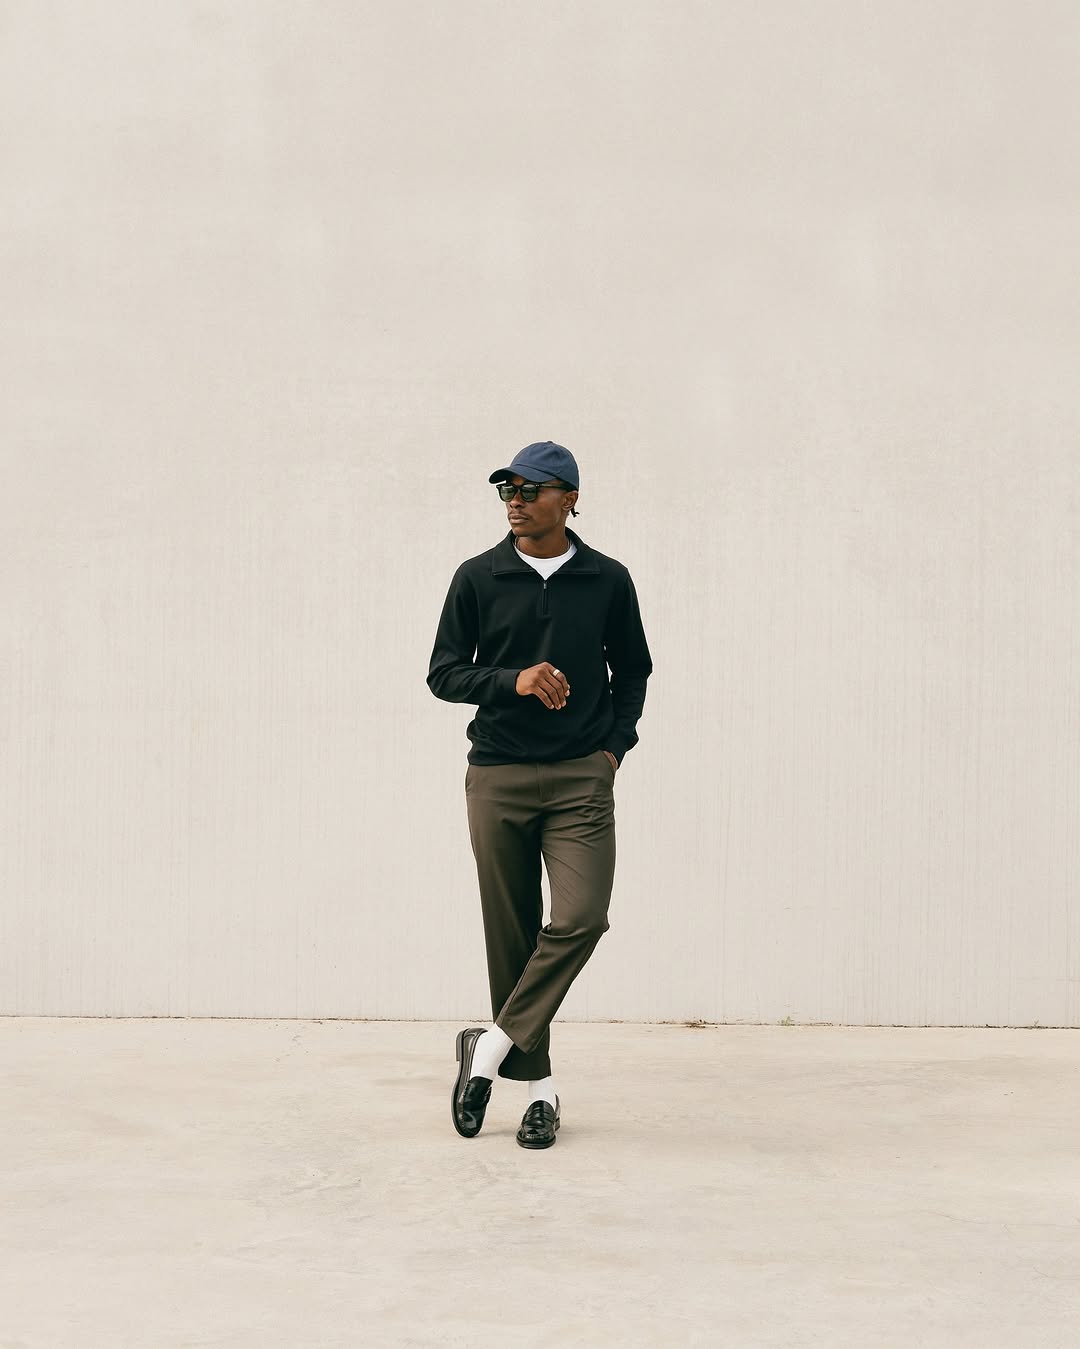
[427,529,653,764]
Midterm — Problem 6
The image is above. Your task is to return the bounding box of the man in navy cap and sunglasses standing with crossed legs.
[427,441,653,1148]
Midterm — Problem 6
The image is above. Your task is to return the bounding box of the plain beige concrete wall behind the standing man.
[0,0,1080,1025]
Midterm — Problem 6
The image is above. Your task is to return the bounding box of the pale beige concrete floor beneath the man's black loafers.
[0,1018,1080,1349]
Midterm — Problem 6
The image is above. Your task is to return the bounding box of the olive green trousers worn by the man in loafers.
[465,750,615,1082]
